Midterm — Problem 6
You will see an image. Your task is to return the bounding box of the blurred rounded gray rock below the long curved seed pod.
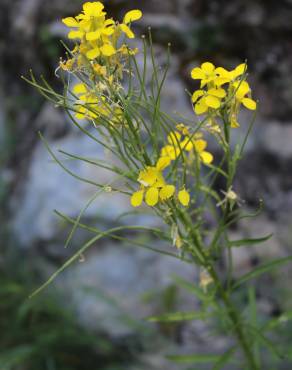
[59,242,198,337]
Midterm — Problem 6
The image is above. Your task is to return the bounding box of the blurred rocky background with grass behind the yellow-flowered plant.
[0,0,292,370]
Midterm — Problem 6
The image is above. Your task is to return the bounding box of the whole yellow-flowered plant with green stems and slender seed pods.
[23,2,291,370]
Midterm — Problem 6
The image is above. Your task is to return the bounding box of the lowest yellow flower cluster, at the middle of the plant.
[131,157,190,207]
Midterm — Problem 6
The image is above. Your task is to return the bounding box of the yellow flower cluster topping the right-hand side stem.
[191,62,256,127]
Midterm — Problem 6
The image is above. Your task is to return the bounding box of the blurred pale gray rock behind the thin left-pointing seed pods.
[13,133,131,246]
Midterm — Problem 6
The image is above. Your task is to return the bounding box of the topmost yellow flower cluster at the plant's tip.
[60,1,142,77]
